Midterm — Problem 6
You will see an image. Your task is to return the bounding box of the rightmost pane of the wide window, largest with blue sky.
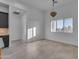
[64,18,73,33]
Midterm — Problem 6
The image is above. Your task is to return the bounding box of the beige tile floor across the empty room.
[3,40,78,59]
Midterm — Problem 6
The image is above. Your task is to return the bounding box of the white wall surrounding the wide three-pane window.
[45,0,78,45]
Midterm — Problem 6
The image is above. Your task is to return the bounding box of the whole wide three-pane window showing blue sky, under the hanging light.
[51,18,73,33]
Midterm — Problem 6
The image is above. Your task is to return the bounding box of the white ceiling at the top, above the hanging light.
[17,0,74,10]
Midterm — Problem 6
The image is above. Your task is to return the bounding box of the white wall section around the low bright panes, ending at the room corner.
[27,6,44,40]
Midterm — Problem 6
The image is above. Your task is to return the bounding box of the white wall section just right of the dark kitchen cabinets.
[9,6,22,40]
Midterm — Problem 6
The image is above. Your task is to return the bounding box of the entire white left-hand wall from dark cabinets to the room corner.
[9,0,43,40]
